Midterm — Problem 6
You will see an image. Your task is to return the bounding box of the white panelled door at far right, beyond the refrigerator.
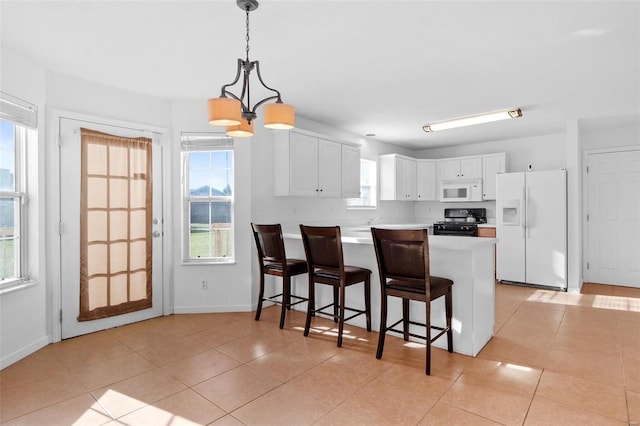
[585,150,640,287]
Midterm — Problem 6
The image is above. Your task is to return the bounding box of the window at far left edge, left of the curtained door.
[0,93,37,290]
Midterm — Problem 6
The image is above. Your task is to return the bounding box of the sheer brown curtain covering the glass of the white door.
[78,129,153,321]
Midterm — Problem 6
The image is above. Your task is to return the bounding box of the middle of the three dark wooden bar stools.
[300,225,371,347]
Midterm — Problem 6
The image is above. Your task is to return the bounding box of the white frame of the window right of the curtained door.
[180,132,236,265]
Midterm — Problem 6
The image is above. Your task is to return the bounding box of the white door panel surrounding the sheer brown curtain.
[59,118,163,339]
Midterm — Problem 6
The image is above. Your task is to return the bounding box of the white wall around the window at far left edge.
[0,46,50,368]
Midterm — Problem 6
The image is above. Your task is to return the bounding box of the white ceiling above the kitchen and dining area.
[0,0,640,149]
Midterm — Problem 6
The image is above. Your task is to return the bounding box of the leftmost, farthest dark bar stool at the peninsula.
[251,223,308,328]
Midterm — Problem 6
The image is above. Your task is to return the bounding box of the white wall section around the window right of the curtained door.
[170,99,254,313]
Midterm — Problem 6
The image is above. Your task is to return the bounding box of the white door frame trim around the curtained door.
[48,109,173,342]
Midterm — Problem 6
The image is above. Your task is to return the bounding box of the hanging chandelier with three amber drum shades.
[208,0,295,137]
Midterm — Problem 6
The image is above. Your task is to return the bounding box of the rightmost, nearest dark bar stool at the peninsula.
[371,228,453,375]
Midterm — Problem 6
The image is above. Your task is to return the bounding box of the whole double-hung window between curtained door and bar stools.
[181,133,235,263]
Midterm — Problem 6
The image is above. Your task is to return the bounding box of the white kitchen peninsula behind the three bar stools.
[284,226,497,356]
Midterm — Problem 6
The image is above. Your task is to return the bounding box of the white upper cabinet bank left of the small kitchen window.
[273,131,360,198]
